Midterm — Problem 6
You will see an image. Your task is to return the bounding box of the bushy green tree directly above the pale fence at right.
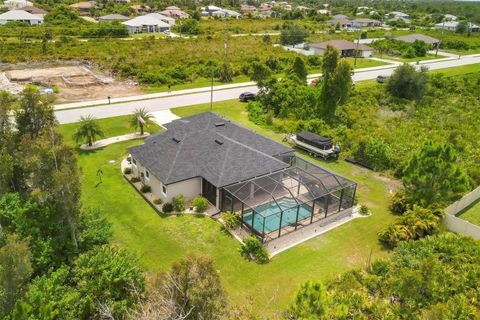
[402,141,470,206]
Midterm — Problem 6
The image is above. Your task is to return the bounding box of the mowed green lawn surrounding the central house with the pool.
[60,101,394,318]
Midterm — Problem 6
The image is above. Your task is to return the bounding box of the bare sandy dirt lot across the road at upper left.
[0,65,142,102]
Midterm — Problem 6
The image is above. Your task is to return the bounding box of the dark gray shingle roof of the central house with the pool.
[129,112,293,187]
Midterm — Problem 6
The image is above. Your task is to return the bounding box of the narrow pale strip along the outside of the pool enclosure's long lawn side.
[265,206,369,257]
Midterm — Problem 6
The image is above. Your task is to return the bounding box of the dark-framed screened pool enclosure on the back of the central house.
[222,156,356,242]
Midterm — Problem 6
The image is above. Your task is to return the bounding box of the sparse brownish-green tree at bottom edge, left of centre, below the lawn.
[160,256,226,320]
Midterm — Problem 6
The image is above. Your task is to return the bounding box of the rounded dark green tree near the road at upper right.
[387,63,428,100]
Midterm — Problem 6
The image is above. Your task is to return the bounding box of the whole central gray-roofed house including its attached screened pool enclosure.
[128,112,356,242]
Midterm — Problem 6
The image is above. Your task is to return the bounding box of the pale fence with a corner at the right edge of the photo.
[444,186,480,239]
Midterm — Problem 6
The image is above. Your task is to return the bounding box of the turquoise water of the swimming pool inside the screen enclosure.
[243,199,312,233]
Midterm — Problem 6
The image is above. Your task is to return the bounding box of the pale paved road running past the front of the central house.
[55,54,480,124]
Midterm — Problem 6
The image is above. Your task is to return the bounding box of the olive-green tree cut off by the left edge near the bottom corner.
[0,234,32,319]
